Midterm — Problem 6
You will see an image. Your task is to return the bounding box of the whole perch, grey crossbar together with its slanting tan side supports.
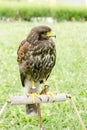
[0,93,86,130]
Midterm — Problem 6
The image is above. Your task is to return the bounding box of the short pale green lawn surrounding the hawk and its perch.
[0,22,87,130]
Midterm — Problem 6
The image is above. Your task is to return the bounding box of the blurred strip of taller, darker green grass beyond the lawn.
[0,1,87,21]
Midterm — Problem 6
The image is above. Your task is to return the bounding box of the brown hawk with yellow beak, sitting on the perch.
[17,26,56,127]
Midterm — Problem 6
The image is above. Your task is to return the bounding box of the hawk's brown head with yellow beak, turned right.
[27,26,56,41]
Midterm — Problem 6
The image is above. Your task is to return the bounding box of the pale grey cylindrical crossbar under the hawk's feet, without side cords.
[10,93,66,105]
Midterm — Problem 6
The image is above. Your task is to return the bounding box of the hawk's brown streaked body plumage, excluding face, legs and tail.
[17,26,56,84]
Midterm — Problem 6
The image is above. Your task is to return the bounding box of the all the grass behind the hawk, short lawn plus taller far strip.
[0,1,87,130]
